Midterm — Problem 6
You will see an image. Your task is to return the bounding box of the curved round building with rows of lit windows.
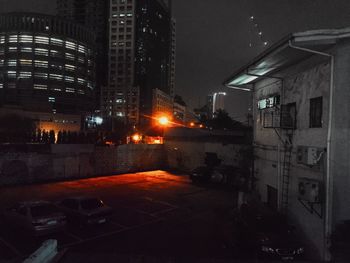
[0,13,95,114]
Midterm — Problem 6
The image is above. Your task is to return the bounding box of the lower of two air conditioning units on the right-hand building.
[298,178,321,204]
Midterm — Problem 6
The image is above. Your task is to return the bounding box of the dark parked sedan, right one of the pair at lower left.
[58,196,113,226]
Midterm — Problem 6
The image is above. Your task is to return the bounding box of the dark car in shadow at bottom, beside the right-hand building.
[237,206,304,260]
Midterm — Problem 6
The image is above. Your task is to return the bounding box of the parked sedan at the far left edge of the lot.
[3,201,66,235]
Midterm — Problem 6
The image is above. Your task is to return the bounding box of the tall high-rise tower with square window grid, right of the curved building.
[102,0,175,127]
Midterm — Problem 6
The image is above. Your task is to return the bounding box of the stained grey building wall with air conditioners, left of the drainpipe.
[253,60,330,258]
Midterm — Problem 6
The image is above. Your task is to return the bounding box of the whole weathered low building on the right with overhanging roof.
[225,28,350,262]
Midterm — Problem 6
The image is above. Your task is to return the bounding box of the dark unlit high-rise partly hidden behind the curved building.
[57,0,110,109]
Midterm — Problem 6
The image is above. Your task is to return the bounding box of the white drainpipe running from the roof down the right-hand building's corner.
[289,40,334,261]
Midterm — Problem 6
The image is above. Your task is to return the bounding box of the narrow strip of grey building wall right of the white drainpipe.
[330,40,350,225]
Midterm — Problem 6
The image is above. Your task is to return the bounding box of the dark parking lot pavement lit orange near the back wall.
[0,171,240,262]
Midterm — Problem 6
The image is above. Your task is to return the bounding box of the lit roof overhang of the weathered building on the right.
[223,28,350,91]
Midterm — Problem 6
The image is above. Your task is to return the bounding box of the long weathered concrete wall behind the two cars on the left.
[0,144,166,185]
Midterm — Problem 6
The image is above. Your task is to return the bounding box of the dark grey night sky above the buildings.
[0,0,350,120]
